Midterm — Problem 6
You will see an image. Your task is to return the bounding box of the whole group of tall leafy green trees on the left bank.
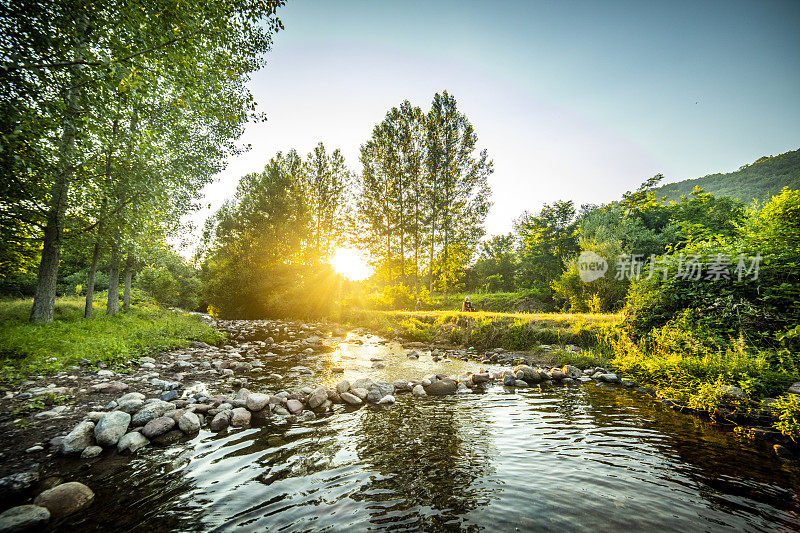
[0,0,282,322]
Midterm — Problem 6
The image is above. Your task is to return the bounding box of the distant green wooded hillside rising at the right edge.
[654,149,800,203]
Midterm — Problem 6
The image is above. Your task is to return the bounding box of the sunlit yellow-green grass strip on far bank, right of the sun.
[345,310,621,359]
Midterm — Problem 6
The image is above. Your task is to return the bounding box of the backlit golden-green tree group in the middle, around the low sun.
[197,91,492,316]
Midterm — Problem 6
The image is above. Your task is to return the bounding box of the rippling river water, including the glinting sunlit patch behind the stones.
[61,335,800,533]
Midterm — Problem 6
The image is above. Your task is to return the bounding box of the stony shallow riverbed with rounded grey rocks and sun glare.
[0,319,796,527]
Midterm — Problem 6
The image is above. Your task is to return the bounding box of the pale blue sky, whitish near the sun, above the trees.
[183,0,800,249]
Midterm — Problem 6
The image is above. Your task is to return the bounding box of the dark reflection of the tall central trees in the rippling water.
[352,398,493,531]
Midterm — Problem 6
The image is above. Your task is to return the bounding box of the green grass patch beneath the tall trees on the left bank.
[0,297,222,382]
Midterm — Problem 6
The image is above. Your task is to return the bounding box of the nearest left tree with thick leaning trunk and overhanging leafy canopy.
[0,0,281,322]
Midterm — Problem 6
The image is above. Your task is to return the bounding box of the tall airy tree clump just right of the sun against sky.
[357,91,492,292]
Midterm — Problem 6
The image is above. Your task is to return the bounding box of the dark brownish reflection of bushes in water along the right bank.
[575,385,800,528]
